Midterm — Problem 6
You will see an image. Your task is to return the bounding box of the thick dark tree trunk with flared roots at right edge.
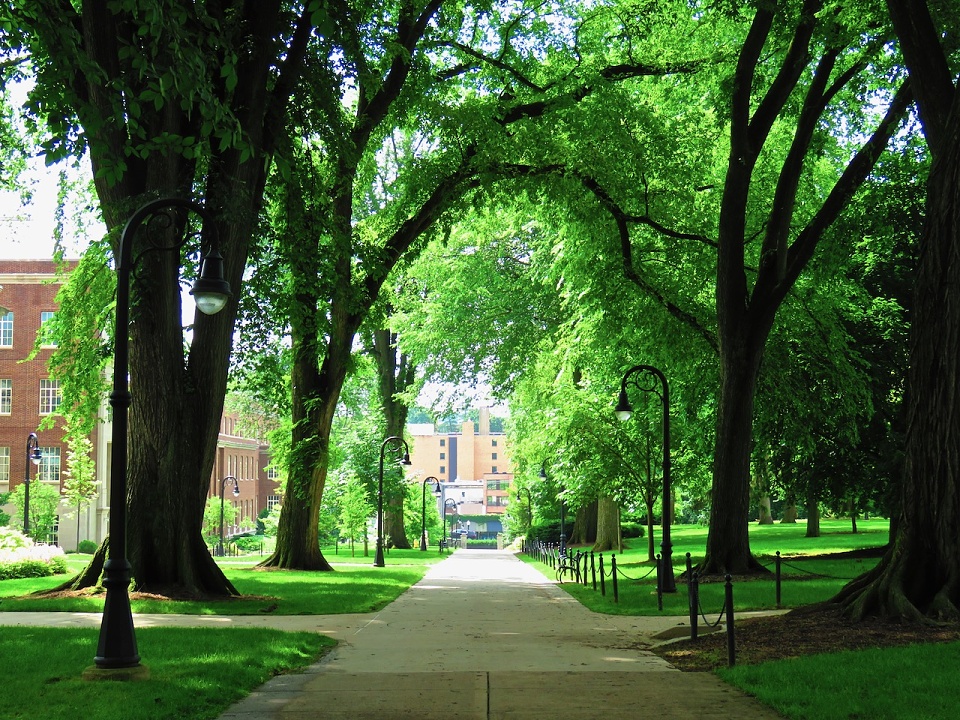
[837,0,960,620]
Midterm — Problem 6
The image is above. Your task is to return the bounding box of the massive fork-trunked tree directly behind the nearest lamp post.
[0,0,325,595]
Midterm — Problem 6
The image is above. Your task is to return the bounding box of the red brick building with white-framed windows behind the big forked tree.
[0,260,282,550]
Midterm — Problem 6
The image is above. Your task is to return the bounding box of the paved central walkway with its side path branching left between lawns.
[0,550,779,720]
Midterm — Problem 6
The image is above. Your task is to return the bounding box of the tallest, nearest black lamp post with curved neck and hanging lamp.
[93,198,230,670]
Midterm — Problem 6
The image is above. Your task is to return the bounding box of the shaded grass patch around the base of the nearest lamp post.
[0,627,334,720]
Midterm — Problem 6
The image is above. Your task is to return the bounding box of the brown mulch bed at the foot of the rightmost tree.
[652,606,960,671]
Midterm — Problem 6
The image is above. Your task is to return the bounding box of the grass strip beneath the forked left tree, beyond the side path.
[0,550,445,615]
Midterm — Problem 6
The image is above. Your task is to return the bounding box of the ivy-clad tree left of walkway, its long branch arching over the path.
[255,0,688,570]
